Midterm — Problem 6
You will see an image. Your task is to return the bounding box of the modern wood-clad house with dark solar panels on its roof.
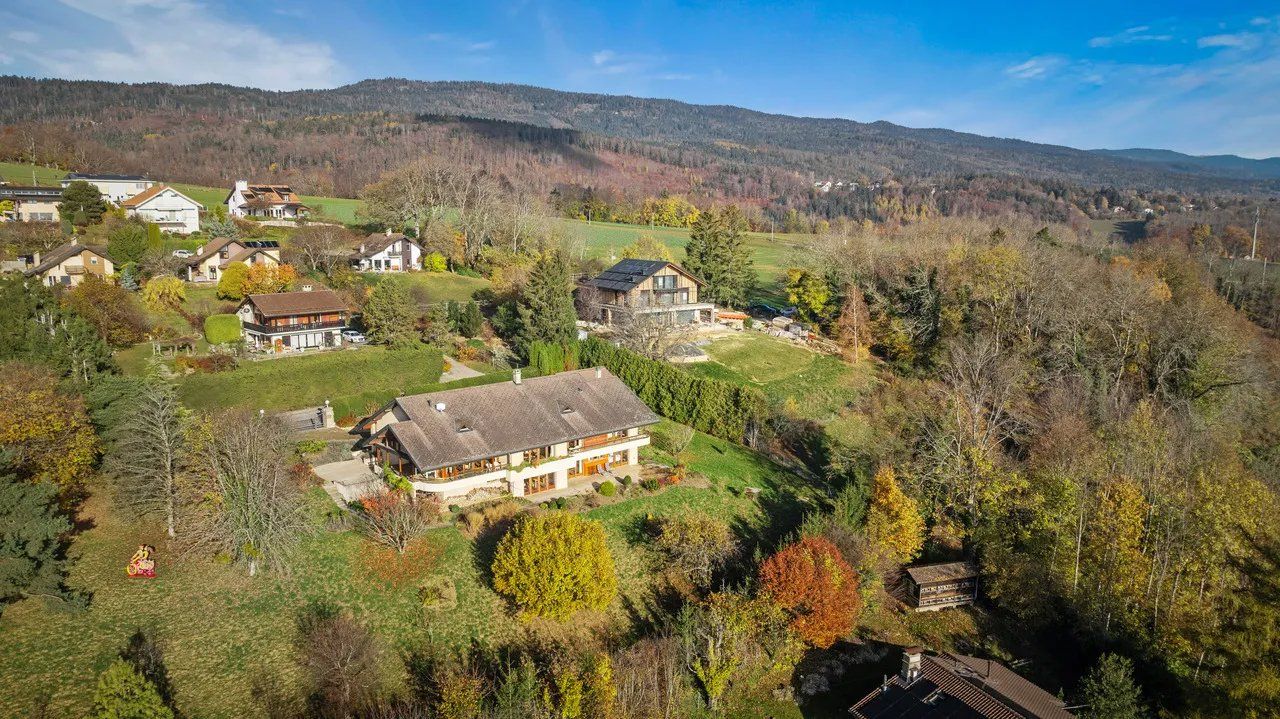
[585,260,716,325]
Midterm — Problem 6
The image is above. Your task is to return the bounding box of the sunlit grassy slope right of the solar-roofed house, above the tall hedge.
[684,331,876,446]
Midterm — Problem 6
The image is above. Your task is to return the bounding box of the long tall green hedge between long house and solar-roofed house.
[577,336,768,443]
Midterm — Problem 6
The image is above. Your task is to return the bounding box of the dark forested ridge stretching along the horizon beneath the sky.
[0,77,1276,191]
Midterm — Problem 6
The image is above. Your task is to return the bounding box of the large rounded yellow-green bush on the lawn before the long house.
[493,512,618,619]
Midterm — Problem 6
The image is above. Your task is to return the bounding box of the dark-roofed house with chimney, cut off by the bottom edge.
[849,646,1075,719]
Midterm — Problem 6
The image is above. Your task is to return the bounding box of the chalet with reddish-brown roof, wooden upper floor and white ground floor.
[236,289,351,352]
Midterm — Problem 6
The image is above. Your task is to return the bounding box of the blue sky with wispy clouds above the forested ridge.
[0,0,1280,157]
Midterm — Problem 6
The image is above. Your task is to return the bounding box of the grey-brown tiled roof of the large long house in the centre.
[376,368,658,471]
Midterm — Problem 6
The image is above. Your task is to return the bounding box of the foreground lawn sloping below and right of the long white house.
[0,427,810,718]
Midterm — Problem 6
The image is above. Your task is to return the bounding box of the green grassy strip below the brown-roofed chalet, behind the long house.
[177,347,443,417]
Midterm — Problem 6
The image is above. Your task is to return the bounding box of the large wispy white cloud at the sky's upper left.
[24,0,343,90]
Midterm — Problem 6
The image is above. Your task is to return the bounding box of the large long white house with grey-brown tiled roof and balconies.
[355,367,658,502]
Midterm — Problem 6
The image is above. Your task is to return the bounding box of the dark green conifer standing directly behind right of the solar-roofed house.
[685,205,755,307]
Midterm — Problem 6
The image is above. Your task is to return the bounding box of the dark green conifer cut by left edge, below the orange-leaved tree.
[0,475,72,612]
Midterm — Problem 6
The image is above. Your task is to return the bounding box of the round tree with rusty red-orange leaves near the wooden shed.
[760,537,861,649]
